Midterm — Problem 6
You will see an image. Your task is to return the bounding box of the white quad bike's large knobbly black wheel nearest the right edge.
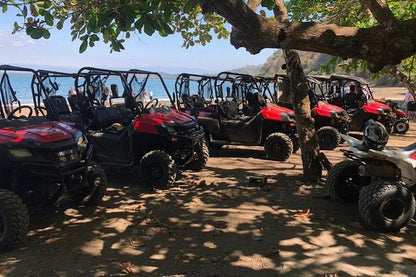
[358,180,415,232]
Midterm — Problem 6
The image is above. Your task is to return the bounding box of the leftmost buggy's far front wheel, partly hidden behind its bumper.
[75,163,107,205]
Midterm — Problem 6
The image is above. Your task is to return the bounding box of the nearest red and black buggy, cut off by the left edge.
[0,65,107,251]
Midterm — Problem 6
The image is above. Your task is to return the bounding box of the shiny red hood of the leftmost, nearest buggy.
[0,122,76,144]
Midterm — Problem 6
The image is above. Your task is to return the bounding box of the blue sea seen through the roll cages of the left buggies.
[0,72,195,104]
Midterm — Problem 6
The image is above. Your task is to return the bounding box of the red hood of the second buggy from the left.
[134,109,195,134]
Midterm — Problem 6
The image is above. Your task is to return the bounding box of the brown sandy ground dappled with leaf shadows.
[0,87,416,276]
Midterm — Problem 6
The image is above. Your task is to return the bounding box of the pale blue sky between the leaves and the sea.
[0,8,275,74]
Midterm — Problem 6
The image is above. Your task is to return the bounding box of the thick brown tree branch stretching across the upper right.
[199,0,416,72]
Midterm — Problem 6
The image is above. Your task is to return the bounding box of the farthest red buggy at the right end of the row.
[314,75,397,133]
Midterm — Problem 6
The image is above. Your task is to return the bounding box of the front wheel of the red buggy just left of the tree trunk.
[264,133,293,161]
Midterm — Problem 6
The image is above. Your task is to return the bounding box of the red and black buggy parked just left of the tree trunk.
[176,72,299,161]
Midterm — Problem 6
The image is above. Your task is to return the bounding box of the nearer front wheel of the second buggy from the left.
[139,150,176,189]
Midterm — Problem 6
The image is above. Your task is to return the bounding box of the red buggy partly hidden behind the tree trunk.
[257,75,351,150]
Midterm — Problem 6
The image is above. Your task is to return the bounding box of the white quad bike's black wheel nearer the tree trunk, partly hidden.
[326,160,371,202]
